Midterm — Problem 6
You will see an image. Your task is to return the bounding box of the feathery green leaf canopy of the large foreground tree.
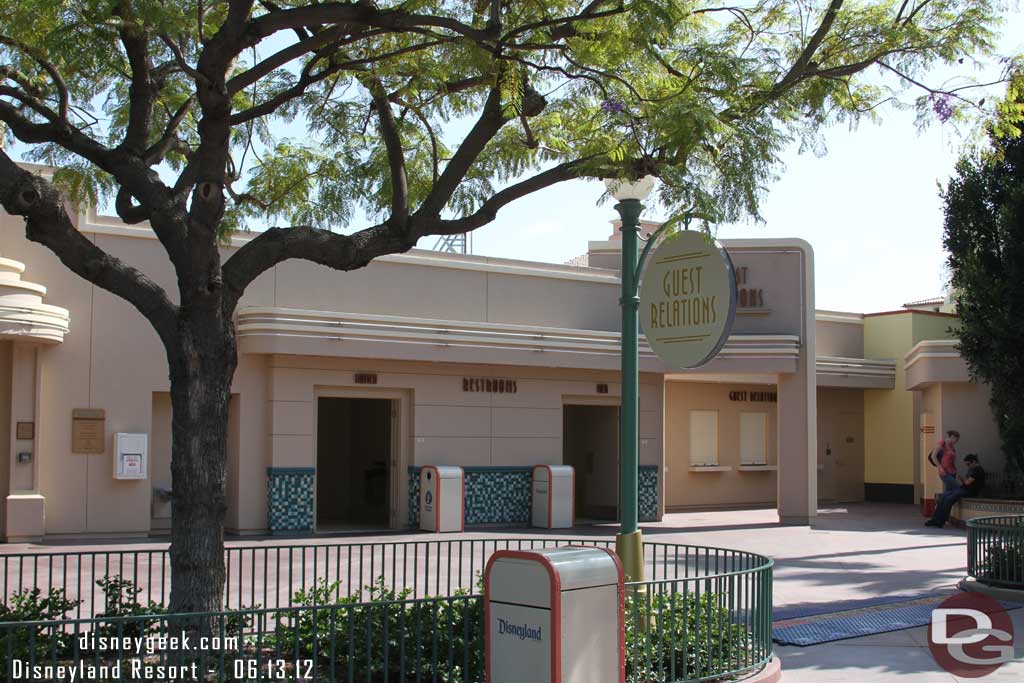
[0,0,1001,232]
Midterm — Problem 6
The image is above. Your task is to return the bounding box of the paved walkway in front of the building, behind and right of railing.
[0,504,1024,683]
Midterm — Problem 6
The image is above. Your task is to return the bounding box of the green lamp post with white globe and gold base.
[604,175,654,581]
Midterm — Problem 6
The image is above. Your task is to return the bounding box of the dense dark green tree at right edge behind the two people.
[943,75,1024,473]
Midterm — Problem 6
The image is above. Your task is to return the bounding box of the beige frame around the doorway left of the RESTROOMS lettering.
[312,385,413,532]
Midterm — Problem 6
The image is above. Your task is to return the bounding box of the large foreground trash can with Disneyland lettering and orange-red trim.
[483,546,626,683]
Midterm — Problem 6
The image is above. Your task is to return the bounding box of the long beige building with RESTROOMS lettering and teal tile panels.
[0,163,990,541]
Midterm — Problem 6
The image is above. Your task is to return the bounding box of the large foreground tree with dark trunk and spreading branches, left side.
[0,0,997,611]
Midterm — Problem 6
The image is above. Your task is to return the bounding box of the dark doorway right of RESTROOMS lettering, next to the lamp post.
[562,405,618,520]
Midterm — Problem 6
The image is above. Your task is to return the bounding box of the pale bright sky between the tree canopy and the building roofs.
[452,11,1024,313]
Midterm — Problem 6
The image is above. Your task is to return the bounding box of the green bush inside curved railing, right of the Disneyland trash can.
[626,590,756,683]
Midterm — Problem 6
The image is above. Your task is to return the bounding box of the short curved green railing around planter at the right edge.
[967,515,1024,589]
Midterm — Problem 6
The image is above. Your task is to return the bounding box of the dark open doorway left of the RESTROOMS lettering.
[316,398,392,531]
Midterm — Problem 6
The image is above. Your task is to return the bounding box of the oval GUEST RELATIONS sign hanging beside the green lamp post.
[640,230,736,369]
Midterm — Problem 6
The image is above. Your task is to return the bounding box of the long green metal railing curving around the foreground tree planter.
[0,537,773,683]
